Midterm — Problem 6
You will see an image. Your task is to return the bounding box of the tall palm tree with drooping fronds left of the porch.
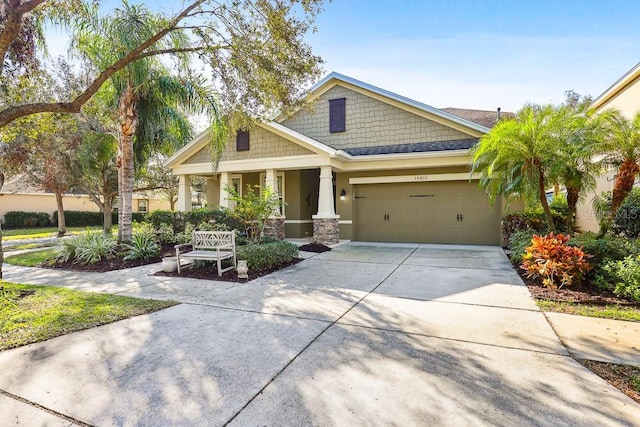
[74,2,222,242]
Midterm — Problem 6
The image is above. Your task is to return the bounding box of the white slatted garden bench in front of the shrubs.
[175,231,236,276]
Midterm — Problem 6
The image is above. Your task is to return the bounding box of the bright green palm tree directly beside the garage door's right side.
[472,105,561,231]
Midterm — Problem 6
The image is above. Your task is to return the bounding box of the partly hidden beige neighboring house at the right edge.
[576,63,640,232]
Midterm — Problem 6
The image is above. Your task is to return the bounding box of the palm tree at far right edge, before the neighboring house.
[606,111,640,218]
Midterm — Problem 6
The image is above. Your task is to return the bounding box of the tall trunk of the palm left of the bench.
[118,83,138,242]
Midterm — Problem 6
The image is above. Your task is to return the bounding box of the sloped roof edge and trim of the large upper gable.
[308,71,489,134]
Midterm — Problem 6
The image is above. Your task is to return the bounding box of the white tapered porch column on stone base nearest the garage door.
[312,166,340,245]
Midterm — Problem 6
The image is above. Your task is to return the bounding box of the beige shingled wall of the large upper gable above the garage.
[282,86,472,149]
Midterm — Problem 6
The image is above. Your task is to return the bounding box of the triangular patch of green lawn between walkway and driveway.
[0,280,177,351]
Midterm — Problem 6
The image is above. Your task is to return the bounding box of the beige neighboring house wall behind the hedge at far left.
[0,193,170,222]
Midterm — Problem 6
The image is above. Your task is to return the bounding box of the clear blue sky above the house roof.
[47,0,640,111]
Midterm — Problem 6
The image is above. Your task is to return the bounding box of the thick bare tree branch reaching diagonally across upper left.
[0,0,205,128]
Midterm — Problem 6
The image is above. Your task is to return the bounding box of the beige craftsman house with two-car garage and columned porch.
[166,73,516,244]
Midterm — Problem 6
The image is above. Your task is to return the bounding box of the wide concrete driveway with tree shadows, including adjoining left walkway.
[0,242,640,426]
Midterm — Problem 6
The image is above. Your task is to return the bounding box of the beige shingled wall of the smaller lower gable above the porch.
[184,126,314,164]
